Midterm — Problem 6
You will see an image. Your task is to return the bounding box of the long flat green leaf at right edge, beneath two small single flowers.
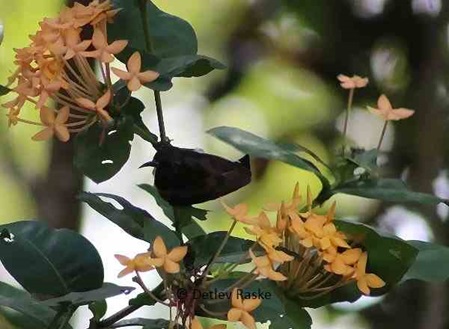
[332,178,448,205]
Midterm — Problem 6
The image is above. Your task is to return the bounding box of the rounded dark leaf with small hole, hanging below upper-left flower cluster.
[74,116,134,183]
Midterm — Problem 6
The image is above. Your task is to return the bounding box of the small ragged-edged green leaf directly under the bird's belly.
[138,184,207,239]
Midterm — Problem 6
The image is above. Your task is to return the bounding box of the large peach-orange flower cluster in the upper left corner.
[3,0,159,142]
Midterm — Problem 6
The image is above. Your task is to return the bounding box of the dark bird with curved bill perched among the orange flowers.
[141,143,251,206]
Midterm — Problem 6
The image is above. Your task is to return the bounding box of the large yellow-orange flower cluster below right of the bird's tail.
[226,184,385,297]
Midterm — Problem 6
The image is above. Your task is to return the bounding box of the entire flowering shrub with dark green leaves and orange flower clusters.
[0,0,449,329]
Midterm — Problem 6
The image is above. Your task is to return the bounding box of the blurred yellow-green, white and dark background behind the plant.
[0,0,449,329]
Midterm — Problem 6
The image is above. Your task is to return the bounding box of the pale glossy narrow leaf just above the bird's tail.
[208,127,329,187]
